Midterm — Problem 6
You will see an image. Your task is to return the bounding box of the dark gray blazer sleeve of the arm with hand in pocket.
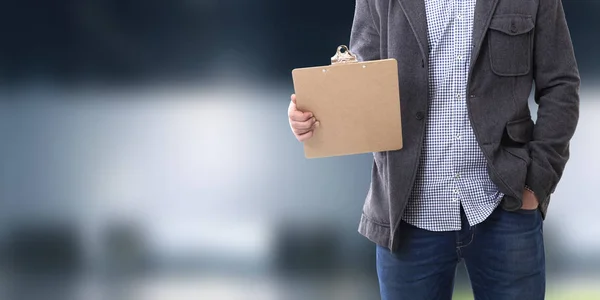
[526,0,580,206]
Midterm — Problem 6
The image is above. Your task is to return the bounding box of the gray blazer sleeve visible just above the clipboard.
[350,0,381,61]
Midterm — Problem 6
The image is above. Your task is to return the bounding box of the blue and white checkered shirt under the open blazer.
[403,0,503,231]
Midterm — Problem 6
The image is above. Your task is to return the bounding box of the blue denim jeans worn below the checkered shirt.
[377,207,546,300]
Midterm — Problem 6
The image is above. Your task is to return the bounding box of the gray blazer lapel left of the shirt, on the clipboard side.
[398,0,429,61]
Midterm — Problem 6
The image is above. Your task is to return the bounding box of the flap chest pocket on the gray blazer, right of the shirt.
[488,15,535,76]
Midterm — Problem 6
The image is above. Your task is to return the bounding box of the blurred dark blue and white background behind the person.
[0,0,600,300]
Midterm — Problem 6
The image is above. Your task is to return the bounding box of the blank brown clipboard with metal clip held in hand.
[292,45,402,158]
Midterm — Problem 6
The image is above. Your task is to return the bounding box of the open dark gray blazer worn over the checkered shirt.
[350,0,580,251]
